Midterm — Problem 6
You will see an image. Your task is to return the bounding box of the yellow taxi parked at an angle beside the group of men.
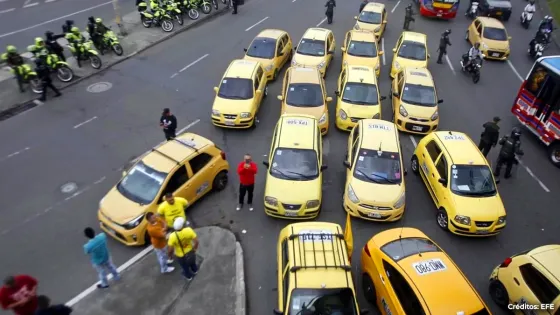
[97,133,229,246]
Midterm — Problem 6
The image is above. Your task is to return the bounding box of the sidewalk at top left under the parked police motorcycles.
[0,7,228,121]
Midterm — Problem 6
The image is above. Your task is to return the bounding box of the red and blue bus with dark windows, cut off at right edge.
[511,56,560,167]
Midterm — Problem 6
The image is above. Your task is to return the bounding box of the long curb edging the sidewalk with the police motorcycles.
[0,7,230,118]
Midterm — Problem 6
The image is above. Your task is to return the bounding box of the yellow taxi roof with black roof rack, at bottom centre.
[280,221,353,289]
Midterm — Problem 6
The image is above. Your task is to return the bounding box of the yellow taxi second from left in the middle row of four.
[278,67,332,135]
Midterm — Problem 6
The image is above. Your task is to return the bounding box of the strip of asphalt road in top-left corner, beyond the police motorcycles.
[0,0,135,52]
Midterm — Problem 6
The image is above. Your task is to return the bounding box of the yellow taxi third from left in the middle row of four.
[334,66,386,131]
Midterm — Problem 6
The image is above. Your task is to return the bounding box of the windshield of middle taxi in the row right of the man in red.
[354,149,402,185]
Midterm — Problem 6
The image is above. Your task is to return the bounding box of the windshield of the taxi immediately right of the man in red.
[270,148,319,181]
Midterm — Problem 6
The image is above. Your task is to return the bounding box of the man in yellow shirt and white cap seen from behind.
[167,218,198,281]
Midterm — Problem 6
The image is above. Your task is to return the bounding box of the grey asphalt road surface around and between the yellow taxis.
[0,0,560,315]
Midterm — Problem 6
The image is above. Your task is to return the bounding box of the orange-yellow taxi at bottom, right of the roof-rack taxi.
[361,228,491,315]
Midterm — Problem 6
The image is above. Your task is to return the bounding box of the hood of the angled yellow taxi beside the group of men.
[99,187,147,224]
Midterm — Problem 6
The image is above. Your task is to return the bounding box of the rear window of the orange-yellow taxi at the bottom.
[381,237,442,262]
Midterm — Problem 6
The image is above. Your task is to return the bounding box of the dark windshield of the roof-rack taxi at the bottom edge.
[286,288,358,315]
